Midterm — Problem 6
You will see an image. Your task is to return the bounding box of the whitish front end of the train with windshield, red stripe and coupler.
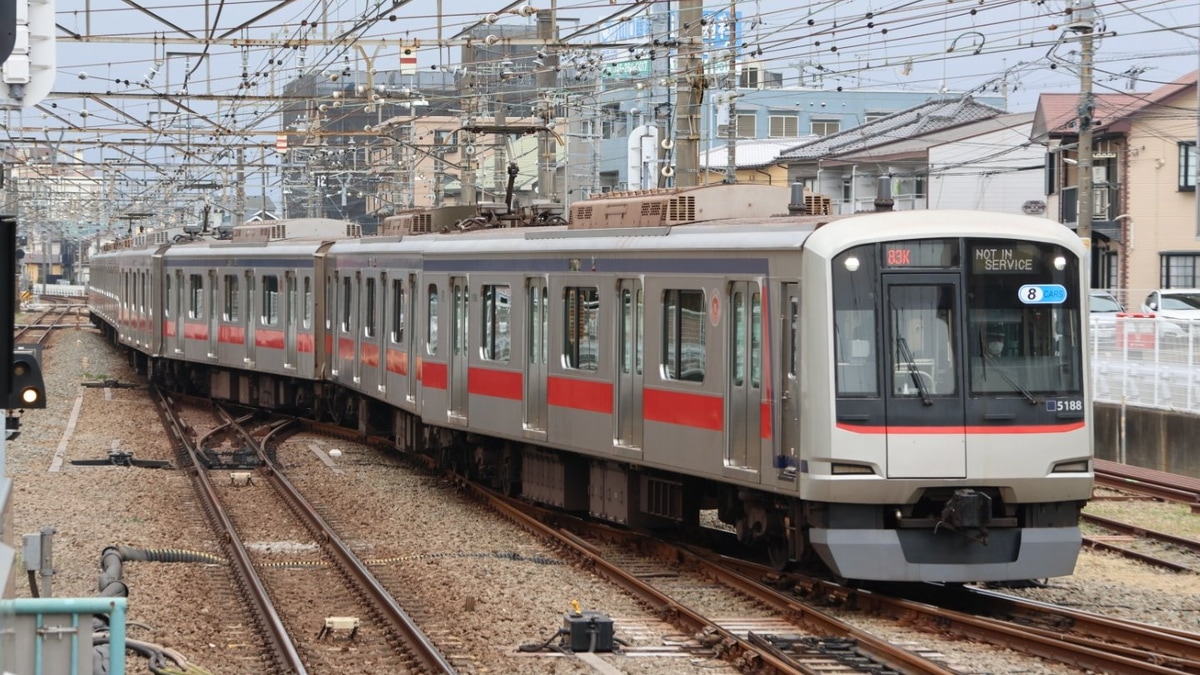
[799,211,1092,583]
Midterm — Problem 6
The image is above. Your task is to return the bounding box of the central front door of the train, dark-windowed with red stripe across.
[883,274,966,478]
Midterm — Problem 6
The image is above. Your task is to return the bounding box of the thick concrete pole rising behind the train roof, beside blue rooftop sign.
[676,0,700,187]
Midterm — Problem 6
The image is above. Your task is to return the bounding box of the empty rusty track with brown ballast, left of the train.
[157,393,455,674]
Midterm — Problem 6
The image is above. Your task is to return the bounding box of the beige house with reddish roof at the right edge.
[1031,72,1200,289]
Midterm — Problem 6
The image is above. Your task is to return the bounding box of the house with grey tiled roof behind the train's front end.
[780,96,1003,214]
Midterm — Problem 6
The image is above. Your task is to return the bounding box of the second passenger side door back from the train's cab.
[616,279,646,449]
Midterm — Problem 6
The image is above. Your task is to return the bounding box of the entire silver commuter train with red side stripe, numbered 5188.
[89,185,1092,583]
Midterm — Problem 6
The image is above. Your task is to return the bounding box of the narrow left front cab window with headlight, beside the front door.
[832,245,880,398]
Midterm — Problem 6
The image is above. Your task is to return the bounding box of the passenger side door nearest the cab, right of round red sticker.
[724,281,762,471]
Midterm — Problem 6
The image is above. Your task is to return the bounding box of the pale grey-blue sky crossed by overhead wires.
[0,0,1200,222]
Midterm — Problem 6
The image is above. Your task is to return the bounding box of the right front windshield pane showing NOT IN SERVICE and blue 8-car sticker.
[965,239,1082,399]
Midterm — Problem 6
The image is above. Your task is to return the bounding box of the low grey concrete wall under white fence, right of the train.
[1094,404,1200,478]
